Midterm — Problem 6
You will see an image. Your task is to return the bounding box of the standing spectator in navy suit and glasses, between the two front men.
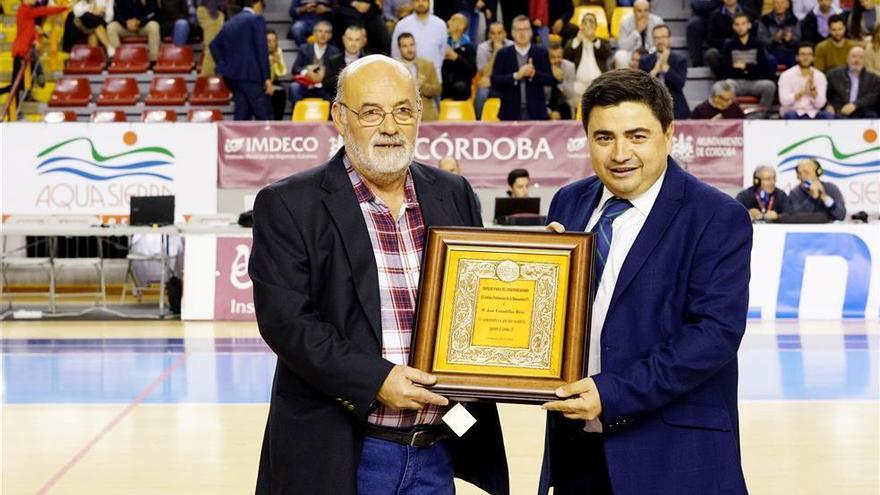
[492,16,556,120]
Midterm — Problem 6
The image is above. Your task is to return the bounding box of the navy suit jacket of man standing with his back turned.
[210,10,269,84]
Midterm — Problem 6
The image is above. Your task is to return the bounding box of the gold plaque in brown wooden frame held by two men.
[410,228,593,403]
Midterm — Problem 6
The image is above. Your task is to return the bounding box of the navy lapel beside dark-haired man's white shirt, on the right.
[608,158,685,314]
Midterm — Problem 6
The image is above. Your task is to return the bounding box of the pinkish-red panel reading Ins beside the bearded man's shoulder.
[214,237,256,320]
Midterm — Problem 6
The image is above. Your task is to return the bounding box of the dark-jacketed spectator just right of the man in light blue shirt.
[440,14,477,101]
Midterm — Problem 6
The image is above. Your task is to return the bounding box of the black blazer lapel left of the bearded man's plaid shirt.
[321,148,382,346]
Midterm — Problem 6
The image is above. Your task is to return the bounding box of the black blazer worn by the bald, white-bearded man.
[249,149,509,495]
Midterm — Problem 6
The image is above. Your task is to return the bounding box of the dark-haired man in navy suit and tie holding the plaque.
[542,69,752,495]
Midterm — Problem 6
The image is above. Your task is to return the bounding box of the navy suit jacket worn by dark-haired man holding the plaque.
[542,159,752,495]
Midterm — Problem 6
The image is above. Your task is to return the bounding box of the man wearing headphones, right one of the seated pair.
[787,158,846,221]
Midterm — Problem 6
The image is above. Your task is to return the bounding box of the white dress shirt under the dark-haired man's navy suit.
[584,170,666,432]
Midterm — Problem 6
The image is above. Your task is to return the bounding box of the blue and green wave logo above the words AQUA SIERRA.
[37,136,174,182]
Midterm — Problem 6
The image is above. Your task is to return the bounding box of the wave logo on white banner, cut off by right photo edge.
[777,133,880,179]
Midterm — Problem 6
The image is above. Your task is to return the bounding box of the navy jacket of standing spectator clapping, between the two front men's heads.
[492,43,557,120]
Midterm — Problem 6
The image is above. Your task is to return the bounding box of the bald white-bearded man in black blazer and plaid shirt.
[249,55,509,495]
